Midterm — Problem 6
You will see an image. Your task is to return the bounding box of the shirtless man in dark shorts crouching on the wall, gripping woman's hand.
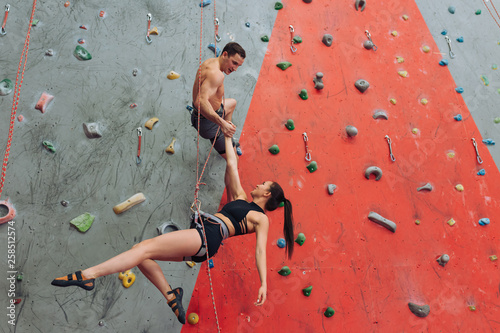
[191,42,246,158]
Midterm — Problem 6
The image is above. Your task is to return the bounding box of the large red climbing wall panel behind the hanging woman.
[183,0,500,332]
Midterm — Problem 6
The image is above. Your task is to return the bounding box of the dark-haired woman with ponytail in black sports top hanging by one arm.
[52,134,294,324]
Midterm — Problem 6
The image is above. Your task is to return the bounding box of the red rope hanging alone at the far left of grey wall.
[0,0,36,197]
